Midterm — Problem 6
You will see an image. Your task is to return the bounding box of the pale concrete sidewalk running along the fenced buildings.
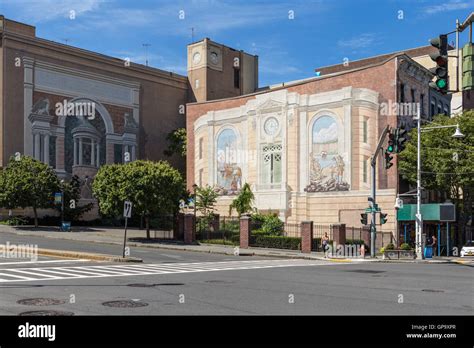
[0,225,469,263]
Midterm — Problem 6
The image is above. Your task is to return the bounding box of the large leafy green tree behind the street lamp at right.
[399,111,474,245]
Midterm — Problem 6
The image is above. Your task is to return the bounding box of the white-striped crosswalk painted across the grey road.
[0,260,333,284]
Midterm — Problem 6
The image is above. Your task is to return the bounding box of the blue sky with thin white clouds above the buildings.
[0,0,474,86]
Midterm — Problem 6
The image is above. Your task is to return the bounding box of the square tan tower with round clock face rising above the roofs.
[188,38,258,102]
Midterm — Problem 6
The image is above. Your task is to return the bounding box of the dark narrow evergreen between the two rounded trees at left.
[55,175,94,221]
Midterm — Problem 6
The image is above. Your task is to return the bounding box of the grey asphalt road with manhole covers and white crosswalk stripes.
[0,235,474,315]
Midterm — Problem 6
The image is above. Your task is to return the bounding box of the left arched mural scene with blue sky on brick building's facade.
[216,129,242,195]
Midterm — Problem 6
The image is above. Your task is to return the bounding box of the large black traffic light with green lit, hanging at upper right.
[430,34,448,94]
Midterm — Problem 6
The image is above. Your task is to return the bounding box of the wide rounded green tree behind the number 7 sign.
[92,161,185,239]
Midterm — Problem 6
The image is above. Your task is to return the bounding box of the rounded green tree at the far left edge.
[0,156,59,227]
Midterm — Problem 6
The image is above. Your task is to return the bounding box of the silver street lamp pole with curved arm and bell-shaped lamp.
[415,107,464,259]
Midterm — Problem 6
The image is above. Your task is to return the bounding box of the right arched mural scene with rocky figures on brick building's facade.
[305,116,349,192]
